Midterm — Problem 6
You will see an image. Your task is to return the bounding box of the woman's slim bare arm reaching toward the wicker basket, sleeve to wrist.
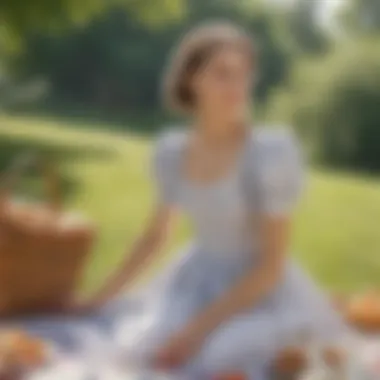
[91,205,173,305]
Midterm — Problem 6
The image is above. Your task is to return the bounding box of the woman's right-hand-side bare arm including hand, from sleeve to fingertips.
[154,216,290,368]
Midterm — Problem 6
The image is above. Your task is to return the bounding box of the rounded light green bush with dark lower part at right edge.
[274,40,380,171]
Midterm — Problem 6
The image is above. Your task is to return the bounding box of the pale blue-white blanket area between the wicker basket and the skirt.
[0,299,140,380]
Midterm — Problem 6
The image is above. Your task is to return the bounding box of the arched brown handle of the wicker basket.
[0,155,62,211]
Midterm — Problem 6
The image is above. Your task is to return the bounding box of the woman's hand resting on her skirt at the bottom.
[153,329,204,370]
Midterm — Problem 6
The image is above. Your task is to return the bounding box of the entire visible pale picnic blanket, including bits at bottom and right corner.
[0,297,380,380]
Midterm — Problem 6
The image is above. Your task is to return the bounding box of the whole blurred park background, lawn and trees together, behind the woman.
[0,0,380,291]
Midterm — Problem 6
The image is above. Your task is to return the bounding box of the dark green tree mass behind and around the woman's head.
[9,0,290,116]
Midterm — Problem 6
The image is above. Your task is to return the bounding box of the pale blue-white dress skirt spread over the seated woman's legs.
[116,246,345,374]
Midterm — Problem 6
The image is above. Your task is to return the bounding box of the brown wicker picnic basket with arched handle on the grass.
[0,156,95,317]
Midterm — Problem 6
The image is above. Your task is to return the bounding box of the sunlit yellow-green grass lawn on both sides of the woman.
[0,116,380,291]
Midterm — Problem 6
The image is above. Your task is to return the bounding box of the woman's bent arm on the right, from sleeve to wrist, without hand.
[184,216,291,337]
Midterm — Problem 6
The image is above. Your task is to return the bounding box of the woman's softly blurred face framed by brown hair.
[192,47,252,122]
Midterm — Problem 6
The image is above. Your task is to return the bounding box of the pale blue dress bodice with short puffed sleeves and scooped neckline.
[154,129,302,256]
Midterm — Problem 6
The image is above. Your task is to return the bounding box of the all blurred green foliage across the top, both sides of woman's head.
[0,0,380,170]
